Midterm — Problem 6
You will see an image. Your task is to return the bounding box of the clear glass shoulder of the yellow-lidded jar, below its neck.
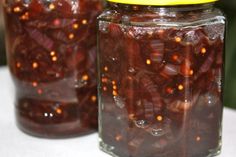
[98,8,227,27]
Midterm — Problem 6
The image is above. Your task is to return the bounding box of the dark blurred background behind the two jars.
[0,0,236,109]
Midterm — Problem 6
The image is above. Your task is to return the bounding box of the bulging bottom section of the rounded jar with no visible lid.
[15,98,97,139]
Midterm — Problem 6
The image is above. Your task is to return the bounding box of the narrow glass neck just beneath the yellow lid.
[108,2,215,14]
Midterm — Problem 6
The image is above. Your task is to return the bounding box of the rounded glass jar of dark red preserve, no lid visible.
[3,0,102,138]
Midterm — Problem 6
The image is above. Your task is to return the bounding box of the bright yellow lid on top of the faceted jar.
[108,0,218,6]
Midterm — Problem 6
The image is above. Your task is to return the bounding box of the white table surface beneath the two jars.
[0,67,236,157]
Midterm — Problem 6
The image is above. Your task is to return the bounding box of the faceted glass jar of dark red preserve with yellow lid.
[98,0,226,157]
